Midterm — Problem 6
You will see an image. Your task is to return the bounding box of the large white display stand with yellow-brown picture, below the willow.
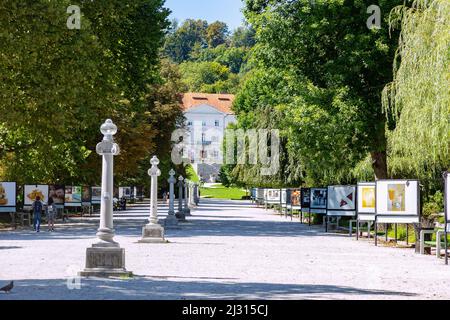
[375,180,420,246]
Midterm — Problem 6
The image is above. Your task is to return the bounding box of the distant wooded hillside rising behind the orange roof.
[163,19,254,93]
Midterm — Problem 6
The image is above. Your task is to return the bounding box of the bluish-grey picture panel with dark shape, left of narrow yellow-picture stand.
[327,186,356,217]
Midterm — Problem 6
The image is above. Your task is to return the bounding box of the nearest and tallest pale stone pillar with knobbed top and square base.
[80,119,131,277]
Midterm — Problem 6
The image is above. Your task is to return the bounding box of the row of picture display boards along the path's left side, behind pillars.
[0,182,143,212]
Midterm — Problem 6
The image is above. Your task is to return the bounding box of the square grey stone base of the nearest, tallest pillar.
[78,247,133,278]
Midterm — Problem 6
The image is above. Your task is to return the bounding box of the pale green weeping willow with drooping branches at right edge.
[383,0,450,190]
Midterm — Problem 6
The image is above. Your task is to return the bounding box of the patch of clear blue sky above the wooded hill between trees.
[165,0,244,30]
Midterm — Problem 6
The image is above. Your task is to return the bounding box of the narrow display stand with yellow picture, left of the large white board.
[356,182,376,240]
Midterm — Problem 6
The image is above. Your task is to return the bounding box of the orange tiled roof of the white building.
[182,92,234,114]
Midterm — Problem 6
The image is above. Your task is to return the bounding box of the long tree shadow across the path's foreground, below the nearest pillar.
[0,276,416,300]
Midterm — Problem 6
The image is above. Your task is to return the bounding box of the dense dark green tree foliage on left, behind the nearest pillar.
[0,0,181,184]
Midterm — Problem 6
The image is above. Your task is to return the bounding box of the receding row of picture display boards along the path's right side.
[251,173,450,232]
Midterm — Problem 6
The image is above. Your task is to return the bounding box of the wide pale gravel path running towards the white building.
[0,200,450,300]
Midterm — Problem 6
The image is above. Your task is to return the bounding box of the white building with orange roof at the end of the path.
[182,93,236,182]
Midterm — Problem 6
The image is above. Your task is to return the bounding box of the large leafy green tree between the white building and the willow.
[229,0,403,186]
